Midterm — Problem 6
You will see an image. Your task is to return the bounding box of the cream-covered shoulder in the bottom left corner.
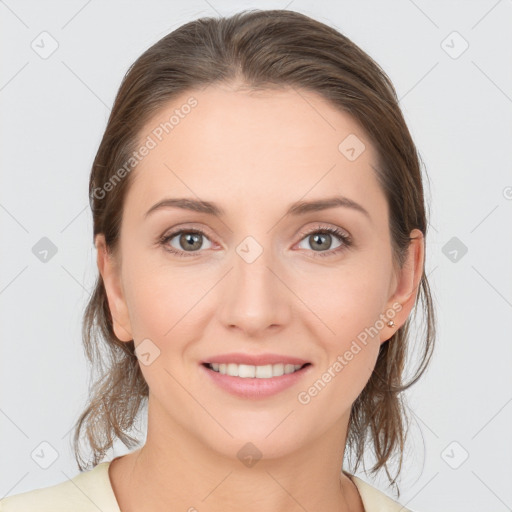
[0,462,120,512]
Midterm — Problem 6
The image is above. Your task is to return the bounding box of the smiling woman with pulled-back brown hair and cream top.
[1,10,435,512]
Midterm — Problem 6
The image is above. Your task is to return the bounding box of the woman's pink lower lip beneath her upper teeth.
[200,364,311,398]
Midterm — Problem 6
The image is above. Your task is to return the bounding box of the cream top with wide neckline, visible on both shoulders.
[0,461,411,512]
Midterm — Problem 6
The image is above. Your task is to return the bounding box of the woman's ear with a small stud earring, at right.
[380,229,425,343]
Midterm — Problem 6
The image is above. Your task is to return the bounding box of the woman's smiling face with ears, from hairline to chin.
[98,86,423,458]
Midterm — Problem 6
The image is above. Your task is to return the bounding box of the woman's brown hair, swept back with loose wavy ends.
[74,10,435,494]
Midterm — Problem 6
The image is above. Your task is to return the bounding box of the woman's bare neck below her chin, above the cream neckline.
[110,400,363,512]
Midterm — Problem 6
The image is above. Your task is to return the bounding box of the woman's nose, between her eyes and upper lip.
[217,246,293,337]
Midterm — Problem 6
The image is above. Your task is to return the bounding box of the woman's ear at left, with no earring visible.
[95,233,133,341]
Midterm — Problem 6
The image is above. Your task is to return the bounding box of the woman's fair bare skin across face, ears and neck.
[96,85,424,512]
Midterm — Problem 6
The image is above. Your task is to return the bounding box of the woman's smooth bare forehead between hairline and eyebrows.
[125,85,385,222]
